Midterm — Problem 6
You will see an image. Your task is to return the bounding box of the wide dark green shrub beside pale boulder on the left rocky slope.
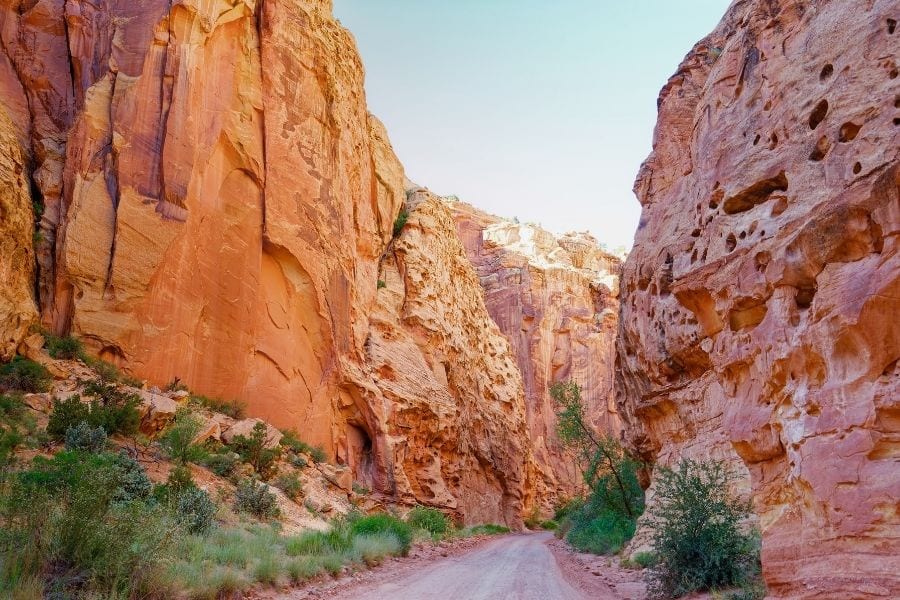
[47,379,141,440]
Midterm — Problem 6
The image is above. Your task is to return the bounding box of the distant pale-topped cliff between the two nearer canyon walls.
[448,201,621,508]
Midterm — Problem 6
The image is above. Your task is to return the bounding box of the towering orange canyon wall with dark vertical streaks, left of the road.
[0,0,534,526]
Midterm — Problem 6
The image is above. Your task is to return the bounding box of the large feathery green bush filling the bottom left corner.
[0,452,177,598]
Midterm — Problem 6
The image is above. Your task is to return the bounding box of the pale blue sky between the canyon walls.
[334,0,729,248]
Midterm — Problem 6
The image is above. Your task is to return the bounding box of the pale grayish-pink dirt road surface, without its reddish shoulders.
[320,533,619,600]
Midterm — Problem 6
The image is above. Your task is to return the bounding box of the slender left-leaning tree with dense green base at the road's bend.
[550,381,644,554]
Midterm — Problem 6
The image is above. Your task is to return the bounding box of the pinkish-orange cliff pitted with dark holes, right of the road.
[618,0,900,598]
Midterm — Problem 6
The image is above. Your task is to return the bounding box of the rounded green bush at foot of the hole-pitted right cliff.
[647,460,759,598]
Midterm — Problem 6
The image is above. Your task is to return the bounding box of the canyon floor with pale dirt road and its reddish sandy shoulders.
[266,532,645,600]
